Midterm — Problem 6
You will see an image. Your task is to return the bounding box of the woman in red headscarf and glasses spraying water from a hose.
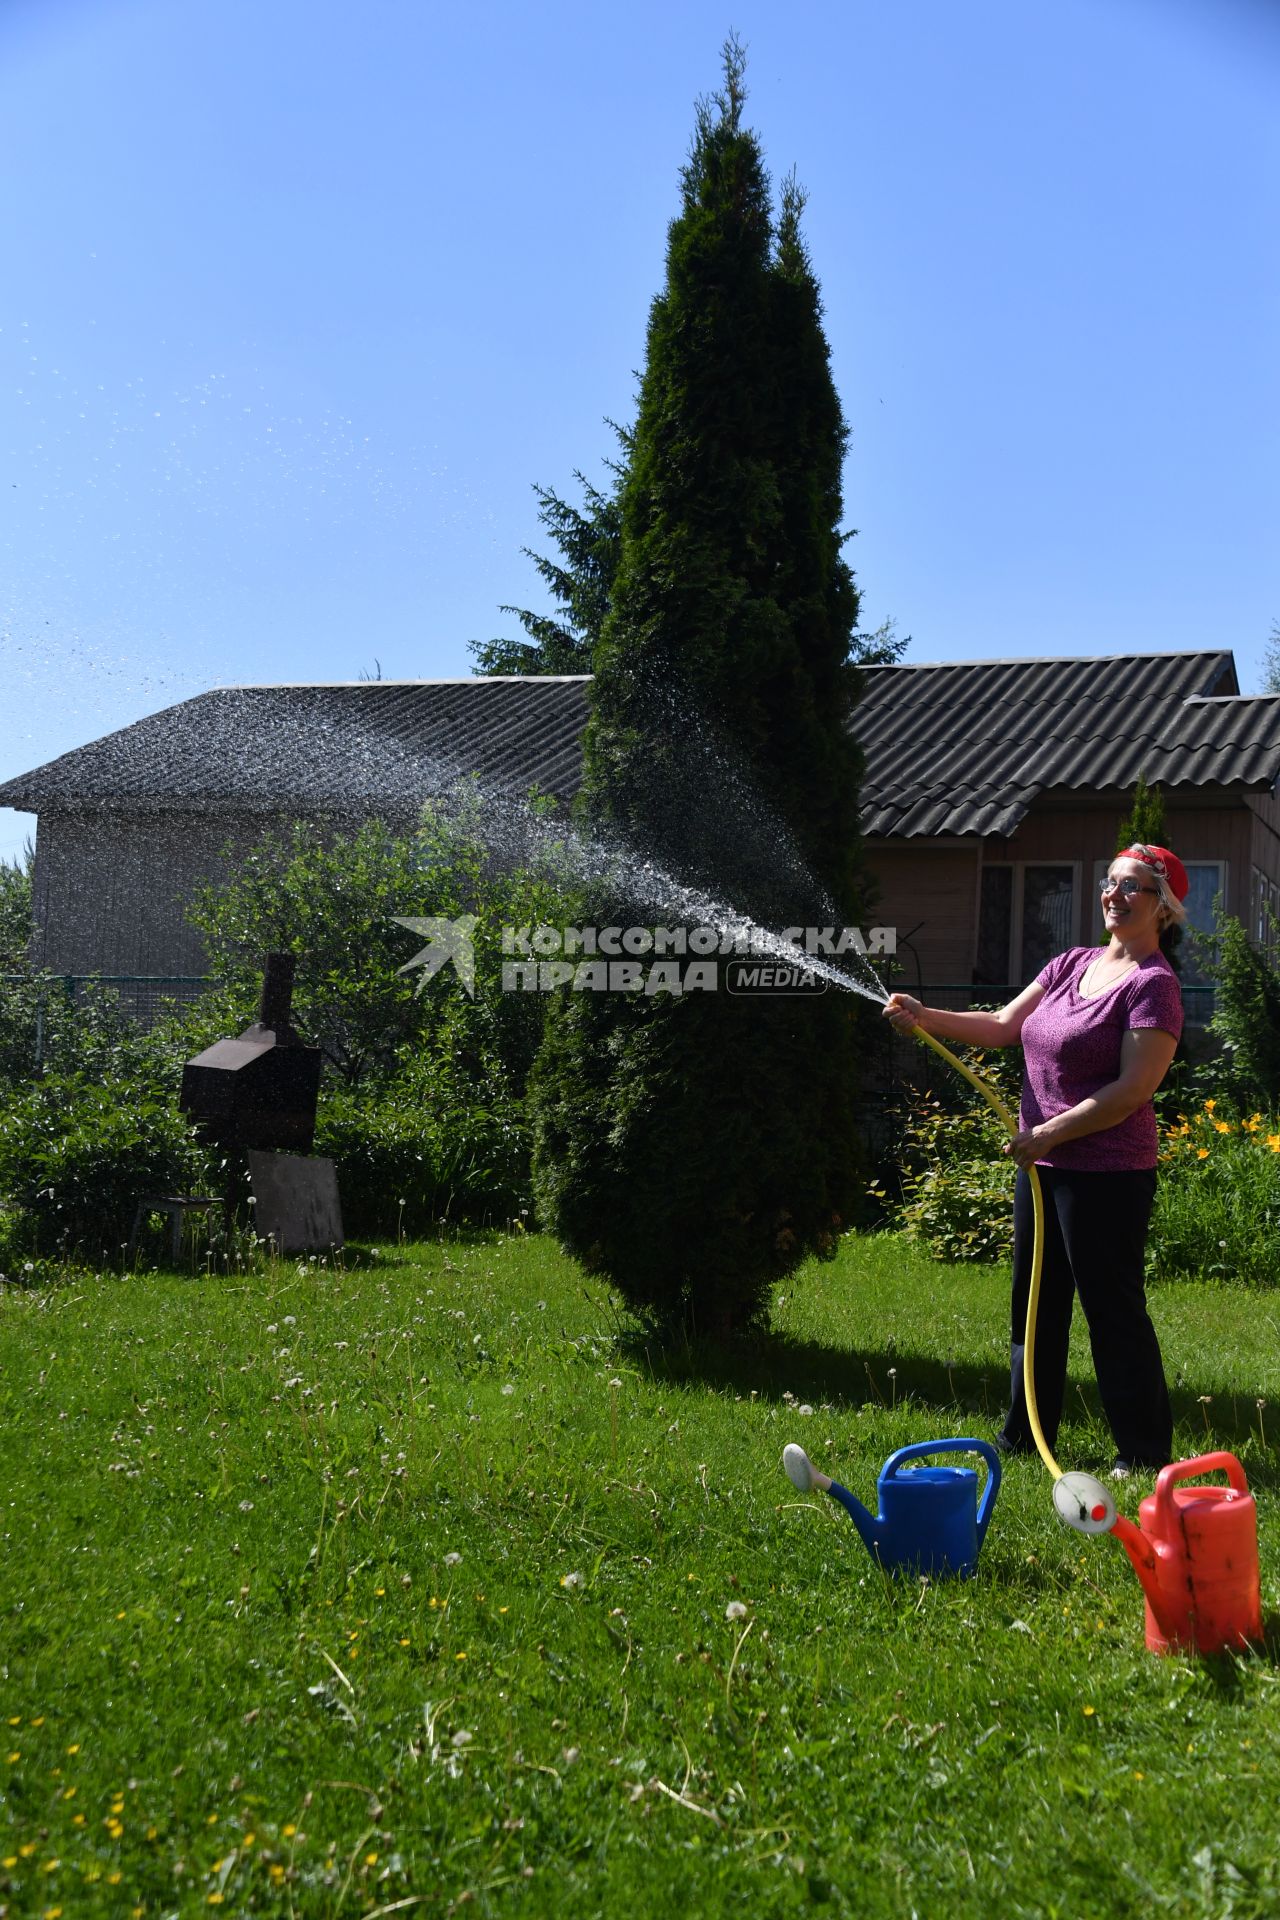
[885,847,1188,1478]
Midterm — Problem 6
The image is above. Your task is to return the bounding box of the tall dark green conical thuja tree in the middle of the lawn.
[533,42,865,1332]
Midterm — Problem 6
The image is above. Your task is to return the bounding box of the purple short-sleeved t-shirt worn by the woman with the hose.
[1021,947,1182,1173]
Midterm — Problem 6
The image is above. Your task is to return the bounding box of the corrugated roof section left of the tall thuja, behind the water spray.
[0,674,589,814]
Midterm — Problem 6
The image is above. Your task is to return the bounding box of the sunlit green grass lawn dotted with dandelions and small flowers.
[0,1236,1280,1920]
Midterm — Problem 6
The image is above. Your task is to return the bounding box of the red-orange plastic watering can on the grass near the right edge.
[1111,1453,1263,1653]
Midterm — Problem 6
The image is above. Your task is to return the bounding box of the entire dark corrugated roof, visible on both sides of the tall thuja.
[0,651,1280,837]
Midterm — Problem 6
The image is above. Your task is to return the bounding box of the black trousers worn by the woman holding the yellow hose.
[1002,1167,1173,1467]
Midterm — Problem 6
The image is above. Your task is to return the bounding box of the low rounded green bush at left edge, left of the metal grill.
[0,1073,207,1260]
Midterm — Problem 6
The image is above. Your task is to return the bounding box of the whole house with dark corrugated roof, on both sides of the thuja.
[0,651,1280,1018]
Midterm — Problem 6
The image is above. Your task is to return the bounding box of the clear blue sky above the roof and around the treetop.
[0,0,1280,856]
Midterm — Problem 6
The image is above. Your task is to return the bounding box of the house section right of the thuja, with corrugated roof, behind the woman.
[854,651,1280,1021]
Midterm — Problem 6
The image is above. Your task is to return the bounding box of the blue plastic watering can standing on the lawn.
[783,1440,1000,1580]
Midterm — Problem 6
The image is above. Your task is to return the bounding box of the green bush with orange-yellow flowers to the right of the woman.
[1148,1100,1280,1286]
